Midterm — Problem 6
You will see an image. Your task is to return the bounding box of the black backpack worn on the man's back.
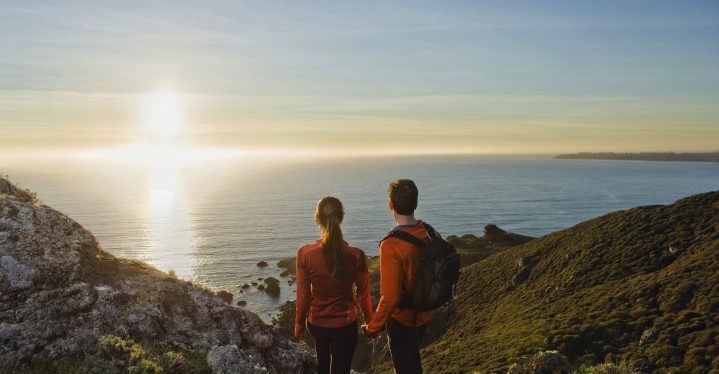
[382,223,460,312]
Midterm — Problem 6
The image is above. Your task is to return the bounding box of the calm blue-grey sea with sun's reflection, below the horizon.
[0,157,719,321]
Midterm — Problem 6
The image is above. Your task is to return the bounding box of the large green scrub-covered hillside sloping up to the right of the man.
[423,192,719,373]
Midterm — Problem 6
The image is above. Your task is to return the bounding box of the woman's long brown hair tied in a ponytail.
[315,196,345,278]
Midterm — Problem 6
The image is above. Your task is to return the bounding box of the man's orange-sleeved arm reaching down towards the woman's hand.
[367,238,404,334]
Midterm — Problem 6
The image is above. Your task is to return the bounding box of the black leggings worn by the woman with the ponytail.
[307,320,357,374]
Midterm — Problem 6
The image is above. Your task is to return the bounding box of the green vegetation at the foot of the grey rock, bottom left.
[2,335,212,374]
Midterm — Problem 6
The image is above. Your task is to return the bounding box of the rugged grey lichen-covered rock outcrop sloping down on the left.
[0,178,314,373]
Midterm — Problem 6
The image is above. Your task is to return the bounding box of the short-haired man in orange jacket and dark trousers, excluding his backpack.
[362,179,432,374]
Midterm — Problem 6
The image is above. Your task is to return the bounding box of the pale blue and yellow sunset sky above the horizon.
[0,0,719,153]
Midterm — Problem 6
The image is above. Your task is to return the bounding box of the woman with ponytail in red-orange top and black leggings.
[295,196,372,374]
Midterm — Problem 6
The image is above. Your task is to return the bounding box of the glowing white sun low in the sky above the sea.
[141,89,184,145]
